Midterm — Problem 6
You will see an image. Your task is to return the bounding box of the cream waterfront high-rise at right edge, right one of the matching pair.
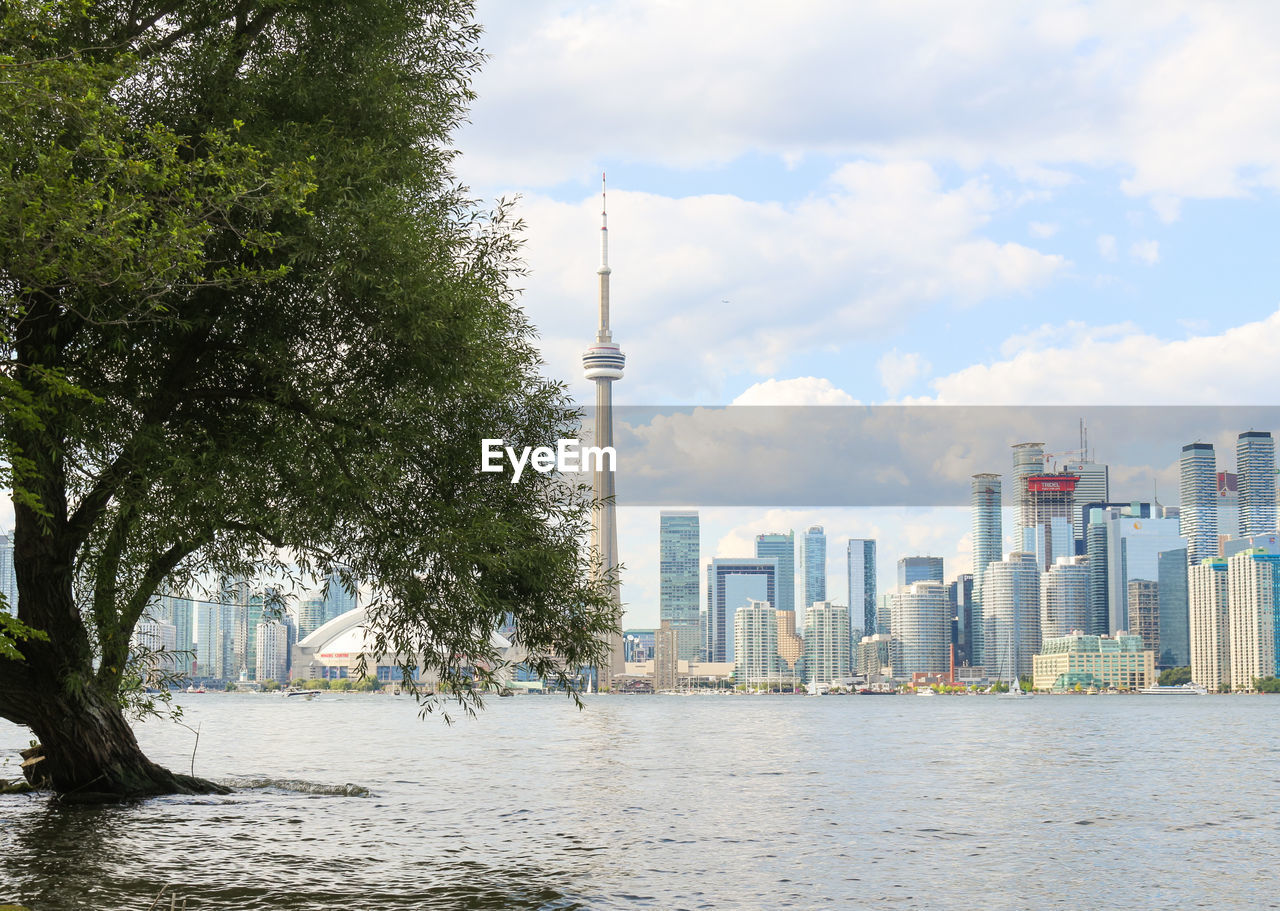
[1226,550,1280,692]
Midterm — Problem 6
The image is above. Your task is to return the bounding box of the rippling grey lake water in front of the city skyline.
[0,693,1280,911]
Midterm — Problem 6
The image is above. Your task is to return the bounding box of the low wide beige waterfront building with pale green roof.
[1032,631,1156,692]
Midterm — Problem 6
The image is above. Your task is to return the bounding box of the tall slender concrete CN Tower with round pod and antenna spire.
[582,174,627,687]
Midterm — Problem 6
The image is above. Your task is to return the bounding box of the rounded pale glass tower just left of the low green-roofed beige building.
[983,553,1041,681]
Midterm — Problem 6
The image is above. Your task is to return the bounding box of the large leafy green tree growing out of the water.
[0,0,618,796]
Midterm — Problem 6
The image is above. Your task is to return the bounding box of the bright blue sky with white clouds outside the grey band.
[456,0,1280,626]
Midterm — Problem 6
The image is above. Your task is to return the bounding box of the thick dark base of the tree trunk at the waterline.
[23,690,228,802]
